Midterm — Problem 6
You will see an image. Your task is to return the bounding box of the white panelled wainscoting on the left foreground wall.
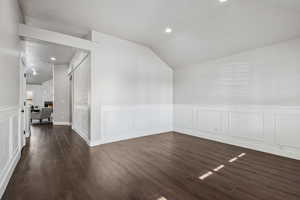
[0,107,21,198]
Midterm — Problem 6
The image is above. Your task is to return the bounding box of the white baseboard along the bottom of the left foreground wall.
[0,151,21,199]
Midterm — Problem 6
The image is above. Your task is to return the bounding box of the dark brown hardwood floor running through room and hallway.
[2,125,300,200]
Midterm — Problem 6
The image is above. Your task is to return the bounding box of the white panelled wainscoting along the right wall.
[174,104,300,159]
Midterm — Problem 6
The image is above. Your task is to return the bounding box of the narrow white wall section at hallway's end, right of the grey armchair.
[53,65,70,125]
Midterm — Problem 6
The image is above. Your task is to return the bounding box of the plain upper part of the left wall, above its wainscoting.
[0,0,20,106]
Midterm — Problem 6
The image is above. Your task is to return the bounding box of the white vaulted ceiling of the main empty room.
[20,0,300,67]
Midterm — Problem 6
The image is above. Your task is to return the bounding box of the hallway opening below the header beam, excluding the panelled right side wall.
[21,39,77,136]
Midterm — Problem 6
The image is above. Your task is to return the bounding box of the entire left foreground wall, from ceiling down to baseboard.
[0,0,21,198]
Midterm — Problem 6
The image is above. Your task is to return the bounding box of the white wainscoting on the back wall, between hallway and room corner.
[92,104,173,146]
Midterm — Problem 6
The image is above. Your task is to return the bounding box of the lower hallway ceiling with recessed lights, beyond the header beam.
[23,40,75,84]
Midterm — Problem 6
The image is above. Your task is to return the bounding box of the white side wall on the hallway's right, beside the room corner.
[72,55,91,142]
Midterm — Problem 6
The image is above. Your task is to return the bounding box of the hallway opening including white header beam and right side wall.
[19,25,94,146]
